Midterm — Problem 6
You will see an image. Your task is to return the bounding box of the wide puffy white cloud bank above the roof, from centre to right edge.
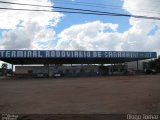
[56,13,160,52]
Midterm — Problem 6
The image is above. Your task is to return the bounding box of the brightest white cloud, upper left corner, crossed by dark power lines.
[0,0,62,29]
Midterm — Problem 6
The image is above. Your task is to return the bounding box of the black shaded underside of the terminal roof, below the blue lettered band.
[0,58,151,65]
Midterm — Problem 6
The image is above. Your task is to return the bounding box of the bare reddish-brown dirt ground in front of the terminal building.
[0,75,160,114]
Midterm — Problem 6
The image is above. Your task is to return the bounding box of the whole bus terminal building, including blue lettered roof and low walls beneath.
[0,50,157,77]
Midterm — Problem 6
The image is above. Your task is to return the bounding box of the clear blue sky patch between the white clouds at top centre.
[54,0,130,33]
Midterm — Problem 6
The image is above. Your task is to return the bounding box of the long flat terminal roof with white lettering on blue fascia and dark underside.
[0,50,157,65]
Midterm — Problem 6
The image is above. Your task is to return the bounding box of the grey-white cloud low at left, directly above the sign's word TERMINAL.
[1,23,55,49]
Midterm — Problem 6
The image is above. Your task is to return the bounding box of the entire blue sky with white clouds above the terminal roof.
[0,0,160,54]
